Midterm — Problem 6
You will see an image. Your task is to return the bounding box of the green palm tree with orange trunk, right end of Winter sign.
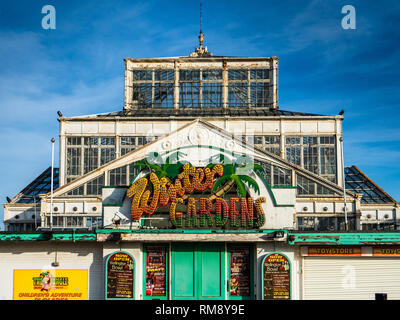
[208,154,264,200]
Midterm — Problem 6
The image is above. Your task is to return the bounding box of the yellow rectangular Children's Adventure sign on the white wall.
[13,269,88,300]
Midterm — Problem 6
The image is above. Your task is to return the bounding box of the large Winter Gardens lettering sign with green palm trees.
[126,159,266,229]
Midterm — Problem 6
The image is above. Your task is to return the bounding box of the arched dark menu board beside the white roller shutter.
[264,253,290,300]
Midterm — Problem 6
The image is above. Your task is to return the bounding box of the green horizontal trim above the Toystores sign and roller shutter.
[288,231,400,245]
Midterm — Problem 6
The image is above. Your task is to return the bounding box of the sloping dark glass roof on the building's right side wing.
[344,166,396,203]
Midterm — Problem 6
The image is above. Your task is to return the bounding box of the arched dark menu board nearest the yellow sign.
[107,252,134,299]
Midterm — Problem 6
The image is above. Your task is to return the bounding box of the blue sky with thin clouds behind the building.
[0,0,400,226]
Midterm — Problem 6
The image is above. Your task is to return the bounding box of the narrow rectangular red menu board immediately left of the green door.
[146,247,167,297]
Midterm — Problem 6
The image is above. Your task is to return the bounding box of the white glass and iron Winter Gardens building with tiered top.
[0,40,400,300]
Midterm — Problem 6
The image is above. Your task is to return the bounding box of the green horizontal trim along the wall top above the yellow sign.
[0,232,97,242]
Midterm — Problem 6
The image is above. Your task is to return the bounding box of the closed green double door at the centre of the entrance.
[171,243,225,300]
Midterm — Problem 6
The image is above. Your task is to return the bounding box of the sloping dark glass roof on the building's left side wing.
[15,167,59,203]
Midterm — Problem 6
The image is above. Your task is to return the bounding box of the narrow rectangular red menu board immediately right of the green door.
[230,247,250,297]
